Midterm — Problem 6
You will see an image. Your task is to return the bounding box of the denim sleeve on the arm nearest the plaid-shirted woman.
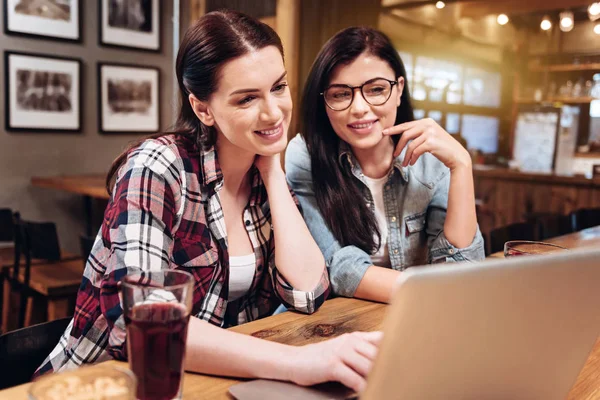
[285,136,373,297]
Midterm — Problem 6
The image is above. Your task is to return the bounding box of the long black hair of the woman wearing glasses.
[301,27,414,253]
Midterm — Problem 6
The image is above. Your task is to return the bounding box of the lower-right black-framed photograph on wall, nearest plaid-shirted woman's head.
[98,63,160,133]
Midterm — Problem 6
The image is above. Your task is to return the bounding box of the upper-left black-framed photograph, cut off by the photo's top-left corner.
[2,0,81,42]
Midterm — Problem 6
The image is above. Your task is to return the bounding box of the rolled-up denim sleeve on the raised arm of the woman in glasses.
[427,173,485,263]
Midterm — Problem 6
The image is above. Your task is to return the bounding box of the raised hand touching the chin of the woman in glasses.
[383,118,471,171]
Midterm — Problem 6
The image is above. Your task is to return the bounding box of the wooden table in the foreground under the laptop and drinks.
[0,298,600,400]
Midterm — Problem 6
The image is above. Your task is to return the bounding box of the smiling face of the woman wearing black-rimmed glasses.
[325,53,404,150]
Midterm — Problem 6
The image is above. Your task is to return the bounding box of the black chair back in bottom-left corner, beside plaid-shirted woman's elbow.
[0,317,71,390]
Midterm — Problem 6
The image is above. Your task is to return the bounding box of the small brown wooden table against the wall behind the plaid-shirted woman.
[31,174,109,237]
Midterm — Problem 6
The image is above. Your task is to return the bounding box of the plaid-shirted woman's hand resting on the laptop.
[289,332,383,392]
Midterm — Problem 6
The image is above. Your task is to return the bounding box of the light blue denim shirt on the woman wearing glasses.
[285,135,485,297]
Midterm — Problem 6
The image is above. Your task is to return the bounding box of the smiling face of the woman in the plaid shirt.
[190,46,292,156]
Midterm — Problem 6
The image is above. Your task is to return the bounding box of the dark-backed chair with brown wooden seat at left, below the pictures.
[3,220,83,329]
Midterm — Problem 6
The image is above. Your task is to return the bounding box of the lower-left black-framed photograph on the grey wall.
[4,51,82,132]
